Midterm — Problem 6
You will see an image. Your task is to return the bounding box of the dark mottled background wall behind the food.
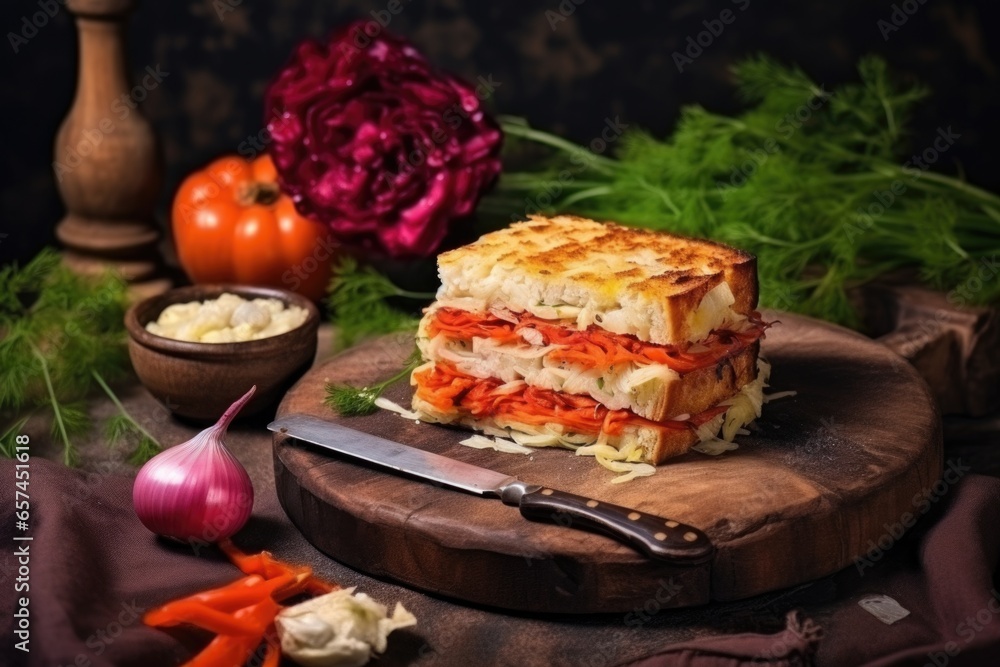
[0,0,1000,261]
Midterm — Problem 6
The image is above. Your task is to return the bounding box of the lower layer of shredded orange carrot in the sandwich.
[413,361,728,437]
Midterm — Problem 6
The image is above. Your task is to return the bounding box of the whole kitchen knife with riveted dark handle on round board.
[267,415,715,565]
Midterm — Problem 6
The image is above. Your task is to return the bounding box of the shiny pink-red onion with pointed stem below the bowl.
[132,385,257,542]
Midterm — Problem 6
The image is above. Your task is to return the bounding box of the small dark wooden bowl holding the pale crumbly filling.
[125,285,319,422]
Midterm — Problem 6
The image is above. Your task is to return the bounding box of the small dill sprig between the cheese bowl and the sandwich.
[328,257,434,350]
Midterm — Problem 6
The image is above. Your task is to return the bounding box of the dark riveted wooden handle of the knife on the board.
[518,487,715,565]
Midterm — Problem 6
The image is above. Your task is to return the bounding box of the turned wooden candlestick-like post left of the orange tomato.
[53,0,170,294]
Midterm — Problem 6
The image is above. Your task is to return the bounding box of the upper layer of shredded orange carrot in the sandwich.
[427,308,770,374]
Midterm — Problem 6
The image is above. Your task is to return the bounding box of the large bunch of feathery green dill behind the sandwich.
[492,56,1000,326]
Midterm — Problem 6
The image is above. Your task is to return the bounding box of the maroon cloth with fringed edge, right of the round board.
[616,475,1000,667]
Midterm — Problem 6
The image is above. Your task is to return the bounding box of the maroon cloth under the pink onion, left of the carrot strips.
[0,458,240,667]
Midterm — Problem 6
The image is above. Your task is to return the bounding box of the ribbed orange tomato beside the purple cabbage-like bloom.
[171,155,337,301]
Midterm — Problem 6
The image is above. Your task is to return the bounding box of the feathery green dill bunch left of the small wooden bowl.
[0,249,160,465]
